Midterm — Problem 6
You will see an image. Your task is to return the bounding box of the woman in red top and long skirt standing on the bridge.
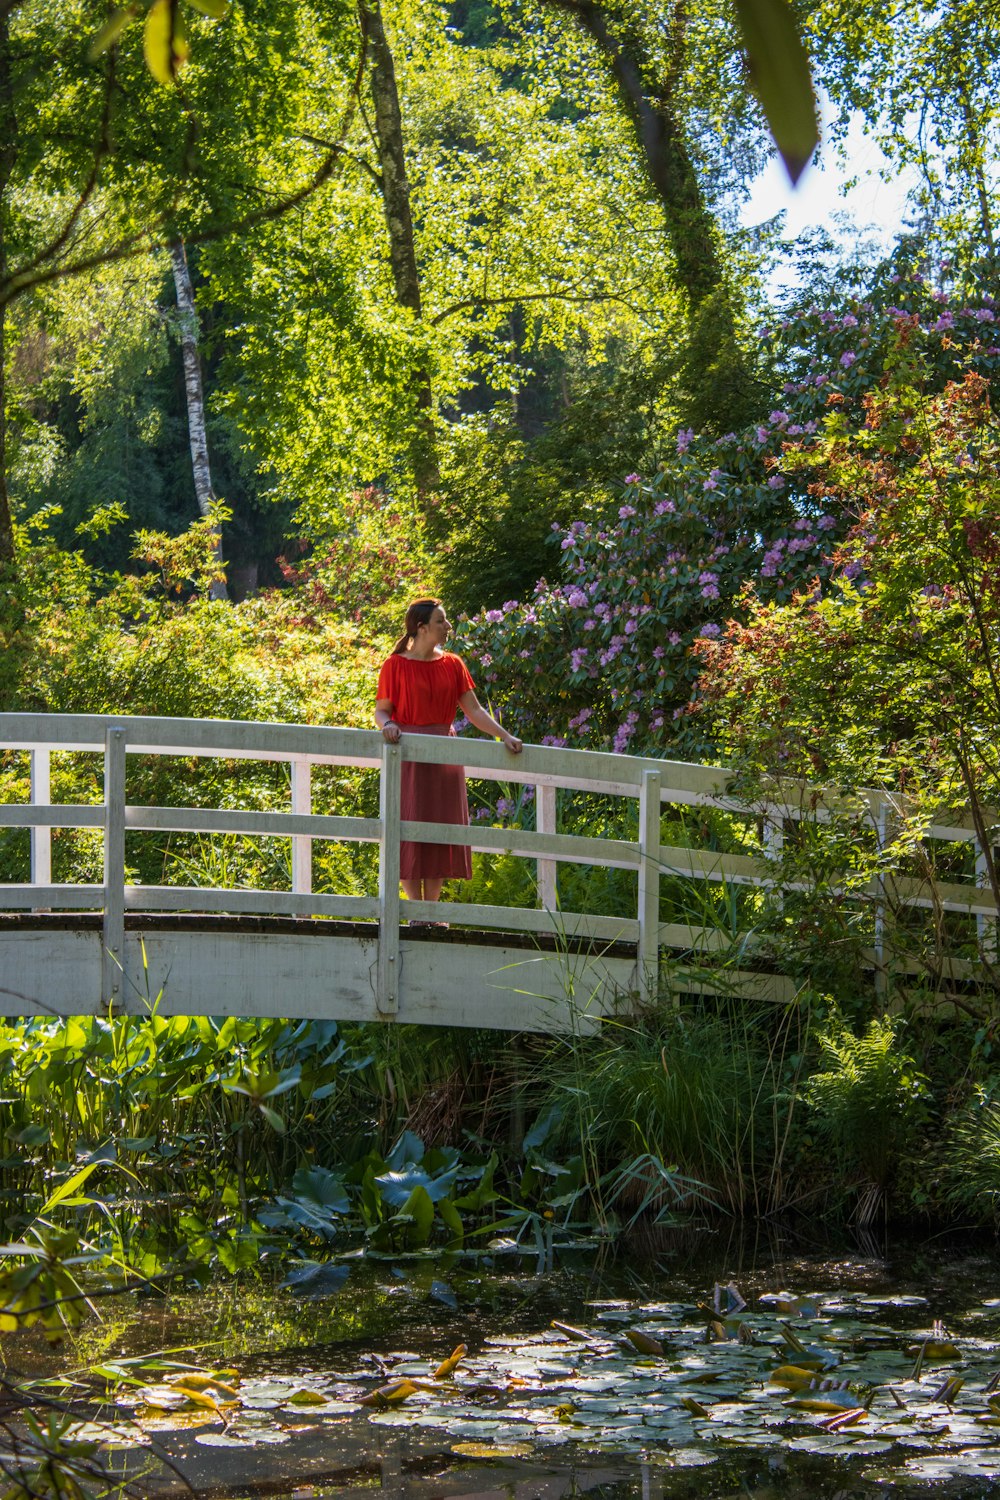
[375,599,522,927]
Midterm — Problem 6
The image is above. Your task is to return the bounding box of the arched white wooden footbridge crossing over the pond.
[0,714,996,1031]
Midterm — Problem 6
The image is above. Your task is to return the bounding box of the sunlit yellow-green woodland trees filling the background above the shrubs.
[0,0,996,630]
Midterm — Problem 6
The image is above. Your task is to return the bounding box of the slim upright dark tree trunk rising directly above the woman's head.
[358,0,439,498]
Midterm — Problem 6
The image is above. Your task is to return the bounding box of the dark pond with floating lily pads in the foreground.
[3,1232,1000,1500]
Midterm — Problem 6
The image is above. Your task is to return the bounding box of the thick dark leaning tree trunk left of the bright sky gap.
[539,0,756,431]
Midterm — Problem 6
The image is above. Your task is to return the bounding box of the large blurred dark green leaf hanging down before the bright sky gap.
[735,0,820,183]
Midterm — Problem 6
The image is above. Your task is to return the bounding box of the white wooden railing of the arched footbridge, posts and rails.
[0,714,997,1014]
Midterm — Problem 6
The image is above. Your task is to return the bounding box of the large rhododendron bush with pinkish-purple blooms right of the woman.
[459,264,1000,752]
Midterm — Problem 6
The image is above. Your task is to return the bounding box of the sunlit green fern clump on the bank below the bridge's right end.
[804,1017,930,1188]
